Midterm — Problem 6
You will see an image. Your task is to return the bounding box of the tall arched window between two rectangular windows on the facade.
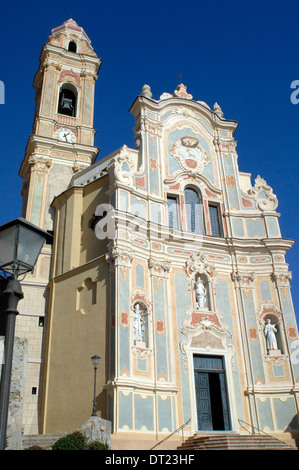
[185,188,204,235]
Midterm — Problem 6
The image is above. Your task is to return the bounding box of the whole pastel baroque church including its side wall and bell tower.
[12,20,299,448]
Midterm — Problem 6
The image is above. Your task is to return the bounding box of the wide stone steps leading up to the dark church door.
[178,432,298,451]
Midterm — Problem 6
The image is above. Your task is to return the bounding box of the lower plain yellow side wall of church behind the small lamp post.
[43,257,109,434]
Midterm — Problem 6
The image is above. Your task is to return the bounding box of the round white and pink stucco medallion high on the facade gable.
[170,136,210,173]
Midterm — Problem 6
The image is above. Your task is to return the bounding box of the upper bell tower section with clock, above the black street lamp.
[20,19,102,230]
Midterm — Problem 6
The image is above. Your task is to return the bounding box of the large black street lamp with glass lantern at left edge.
[0,217,53,450]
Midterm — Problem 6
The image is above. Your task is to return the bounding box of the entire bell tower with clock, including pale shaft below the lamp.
[16,19,102,434]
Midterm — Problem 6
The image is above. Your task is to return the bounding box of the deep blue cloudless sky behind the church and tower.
[0,0,299,322]
